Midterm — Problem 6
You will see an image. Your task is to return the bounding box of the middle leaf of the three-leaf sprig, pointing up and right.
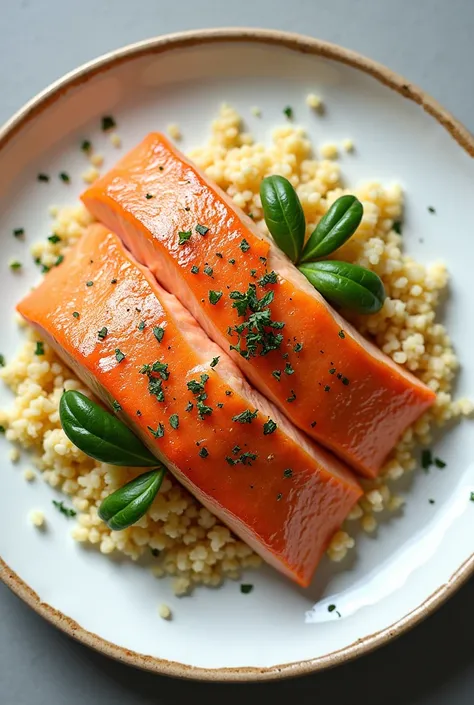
[301,196,364,262]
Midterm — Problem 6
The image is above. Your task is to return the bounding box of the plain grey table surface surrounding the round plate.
[0,0,474,705]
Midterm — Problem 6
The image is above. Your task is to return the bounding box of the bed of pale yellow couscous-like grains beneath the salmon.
[0,103,473,594]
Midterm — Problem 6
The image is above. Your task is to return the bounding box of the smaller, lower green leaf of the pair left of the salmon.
[98,466,166,531]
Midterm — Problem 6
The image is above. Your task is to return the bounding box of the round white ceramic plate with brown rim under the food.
[0,30,474,680]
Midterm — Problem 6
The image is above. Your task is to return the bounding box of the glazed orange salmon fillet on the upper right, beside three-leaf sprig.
[82,133,435,477]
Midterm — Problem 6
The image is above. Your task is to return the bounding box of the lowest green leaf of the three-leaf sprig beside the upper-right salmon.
[299,260,385,314]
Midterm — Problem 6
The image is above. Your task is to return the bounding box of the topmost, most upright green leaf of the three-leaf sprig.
[260,175,306,262]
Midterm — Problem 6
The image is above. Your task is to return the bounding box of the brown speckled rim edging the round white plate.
[0,28,474,682]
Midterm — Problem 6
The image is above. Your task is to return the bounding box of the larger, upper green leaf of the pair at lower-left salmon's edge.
[59,390,158,467]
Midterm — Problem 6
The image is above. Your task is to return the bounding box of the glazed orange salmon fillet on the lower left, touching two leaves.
[18,225,361,586]
